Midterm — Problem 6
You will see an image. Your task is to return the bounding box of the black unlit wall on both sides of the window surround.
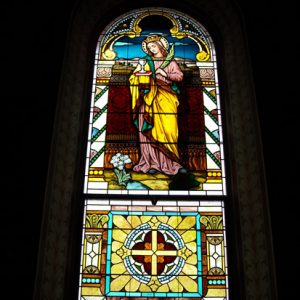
[1,0,299,299]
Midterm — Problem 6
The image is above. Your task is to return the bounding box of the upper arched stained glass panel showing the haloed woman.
[84,8,226,195]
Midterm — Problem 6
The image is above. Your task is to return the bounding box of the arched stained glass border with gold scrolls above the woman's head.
[99,7,214,61]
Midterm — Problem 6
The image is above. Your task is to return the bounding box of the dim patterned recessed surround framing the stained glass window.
[35,1,276,299]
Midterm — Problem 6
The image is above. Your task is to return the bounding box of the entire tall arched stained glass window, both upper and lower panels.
[79,8,229,300]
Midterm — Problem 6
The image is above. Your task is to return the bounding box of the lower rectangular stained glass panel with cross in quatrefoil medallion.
[79,200,229,300]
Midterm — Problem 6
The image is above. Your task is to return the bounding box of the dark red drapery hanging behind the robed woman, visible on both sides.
[105,85,206,171]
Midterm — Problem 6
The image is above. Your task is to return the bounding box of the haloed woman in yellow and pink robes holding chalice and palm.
[129,35,186,175]
